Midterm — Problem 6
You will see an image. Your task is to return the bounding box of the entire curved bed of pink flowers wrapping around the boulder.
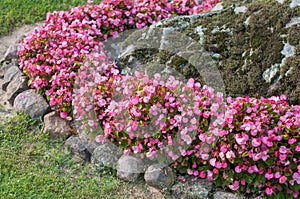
[18,0,300,198]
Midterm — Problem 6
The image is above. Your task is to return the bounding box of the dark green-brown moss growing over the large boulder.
[120,0,300,104]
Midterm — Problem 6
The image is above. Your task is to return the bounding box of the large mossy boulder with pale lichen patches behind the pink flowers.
[118,0,300,104]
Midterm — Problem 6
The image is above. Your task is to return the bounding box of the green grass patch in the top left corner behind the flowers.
[0,0,101,36]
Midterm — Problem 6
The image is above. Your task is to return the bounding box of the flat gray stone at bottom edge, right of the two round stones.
[171,179,212,199]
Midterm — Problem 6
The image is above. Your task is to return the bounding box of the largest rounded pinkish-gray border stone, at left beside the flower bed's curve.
[14,89,50,119]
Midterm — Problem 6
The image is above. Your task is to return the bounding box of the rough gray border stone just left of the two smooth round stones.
[91,142,122,170]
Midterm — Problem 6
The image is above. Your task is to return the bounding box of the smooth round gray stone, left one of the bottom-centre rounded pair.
[117,155,144,181]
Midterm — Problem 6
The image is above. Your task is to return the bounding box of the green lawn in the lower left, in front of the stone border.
[0,114,162,199]
